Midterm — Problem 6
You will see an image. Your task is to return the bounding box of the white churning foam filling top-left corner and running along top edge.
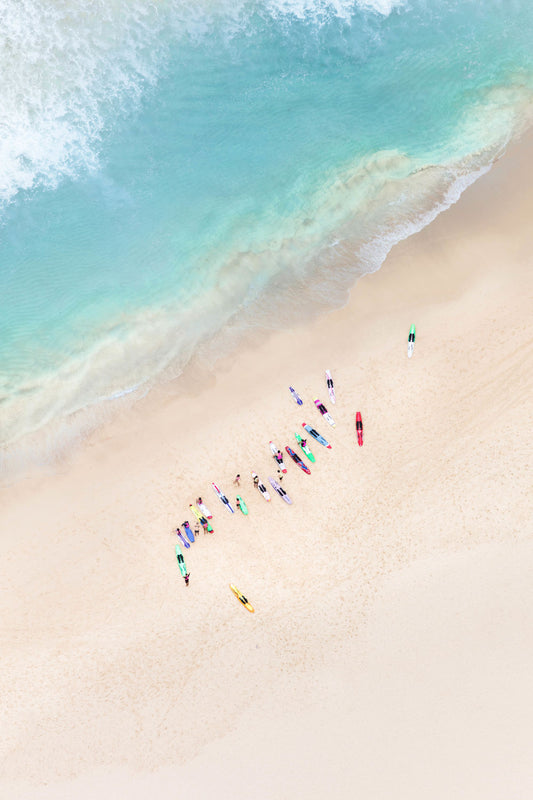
[0,0,404,205]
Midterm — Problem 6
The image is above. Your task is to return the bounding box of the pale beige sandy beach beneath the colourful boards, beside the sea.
[0,136,533,800]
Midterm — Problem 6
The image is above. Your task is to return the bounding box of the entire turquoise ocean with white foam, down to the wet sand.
[0,0,533,469]
